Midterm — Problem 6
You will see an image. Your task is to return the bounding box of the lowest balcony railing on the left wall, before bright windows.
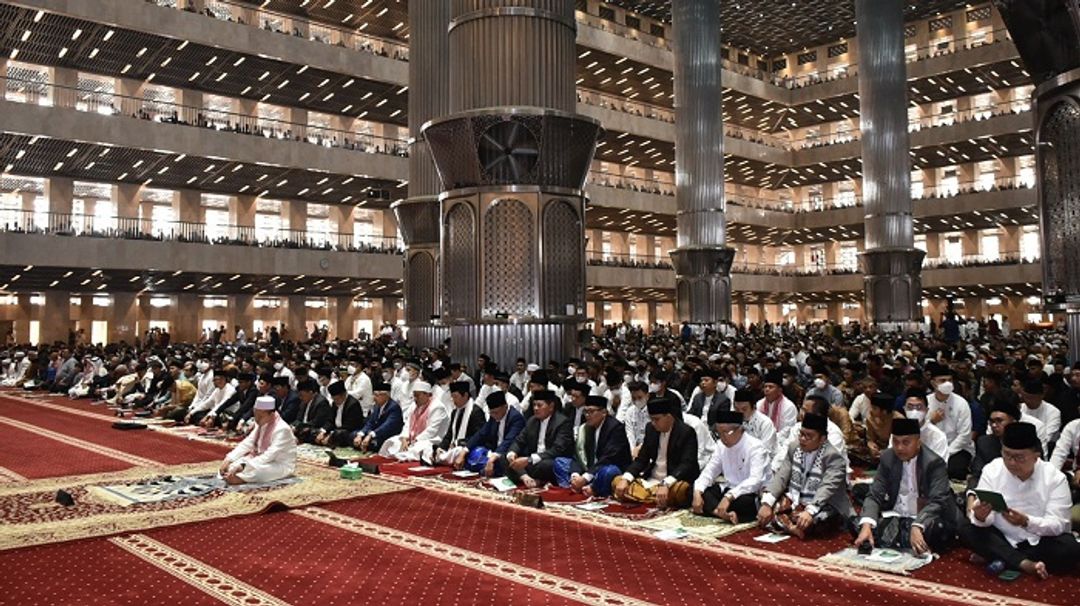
[0,210,402,255]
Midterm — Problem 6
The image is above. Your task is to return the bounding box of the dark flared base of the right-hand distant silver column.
[862,248,927,325]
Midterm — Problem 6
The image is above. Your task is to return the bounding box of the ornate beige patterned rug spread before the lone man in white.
[0,461,408,550]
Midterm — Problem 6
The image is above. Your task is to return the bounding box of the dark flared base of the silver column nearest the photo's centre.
[669,247,735,324]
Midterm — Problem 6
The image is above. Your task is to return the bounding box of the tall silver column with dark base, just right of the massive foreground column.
[671,0,734,324]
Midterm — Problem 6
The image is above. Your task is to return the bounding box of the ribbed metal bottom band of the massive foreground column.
[449,321,581,368]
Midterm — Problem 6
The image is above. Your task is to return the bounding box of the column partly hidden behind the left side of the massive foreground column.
[391,0,450,347]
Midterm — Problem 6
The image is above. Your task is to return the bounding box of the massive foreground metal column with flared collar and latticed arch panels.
[423,0,600,366]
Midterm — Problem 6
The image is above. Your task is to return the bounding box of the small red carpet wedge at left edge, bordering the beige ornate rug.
[0,426,131,480]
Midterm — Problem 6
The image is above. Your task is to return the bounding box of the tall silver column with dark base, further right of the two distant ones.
[855,0,924,331]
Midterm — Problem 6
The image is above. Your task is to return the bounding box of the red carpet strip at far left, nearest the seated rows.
[0,396,227,464]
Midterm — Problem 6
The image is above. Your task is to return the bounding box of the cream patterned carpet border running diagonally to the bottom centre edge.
[291,507,651,606]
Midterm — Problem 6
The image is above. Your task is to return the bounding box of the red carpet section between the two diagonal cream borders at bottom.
[147,507,578,605]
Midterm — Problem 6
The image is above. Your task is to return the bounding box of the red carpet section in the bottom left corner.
[0,539,221,606]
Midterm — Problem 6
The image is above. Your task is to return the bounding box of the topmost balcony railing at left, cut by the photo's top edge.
[146,0,408,62]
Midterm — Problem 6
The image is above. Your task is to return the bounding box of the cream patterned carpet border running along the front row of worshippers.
[373,475,1042,606]
